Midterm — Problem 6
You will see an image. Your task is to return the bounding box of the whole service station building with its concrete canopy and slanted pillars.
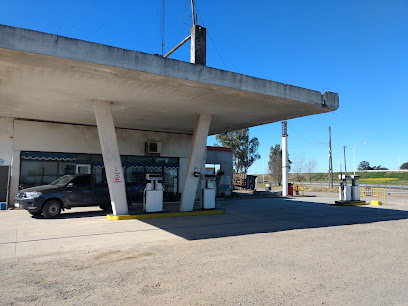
[0,25,339,216]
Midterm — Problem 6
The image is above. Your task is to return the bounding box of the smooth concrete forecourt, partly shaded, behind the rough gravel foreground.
[0,193,408,258]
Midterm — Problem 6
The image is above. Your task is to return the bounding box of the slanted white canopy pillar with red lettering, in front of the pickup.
[93,101,129,215]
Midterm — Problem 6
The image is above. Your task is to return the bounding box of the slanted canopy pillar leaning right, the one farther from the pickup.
[180,114,211,211]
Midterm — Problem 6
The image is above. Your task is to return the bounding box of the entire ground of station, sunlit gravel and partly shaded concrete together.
[0,194,408,305]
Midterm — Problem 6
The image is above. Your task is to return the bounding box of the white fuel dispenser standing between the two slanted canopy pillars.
[143,173,163,212]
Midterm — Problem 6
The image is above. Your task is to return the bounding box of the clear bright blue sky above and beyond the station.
[0,0,408,173]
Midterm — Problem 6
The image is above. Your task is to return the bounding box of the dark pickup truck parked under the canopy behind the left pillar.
[14,174,145,218]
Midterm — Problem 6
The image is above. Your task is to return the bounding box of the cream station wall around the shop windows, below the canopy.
[8,119,192,198]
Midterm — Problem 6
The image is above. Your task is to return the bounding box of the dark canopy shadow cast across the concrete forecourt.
[135,198,408,240]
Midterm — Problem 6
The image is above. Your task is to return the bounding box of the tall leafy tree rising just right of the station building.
[215,128,261,173]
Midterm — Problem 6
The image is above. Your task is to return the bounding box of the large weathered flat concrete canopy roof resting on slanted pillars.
[0,25,339,135]
